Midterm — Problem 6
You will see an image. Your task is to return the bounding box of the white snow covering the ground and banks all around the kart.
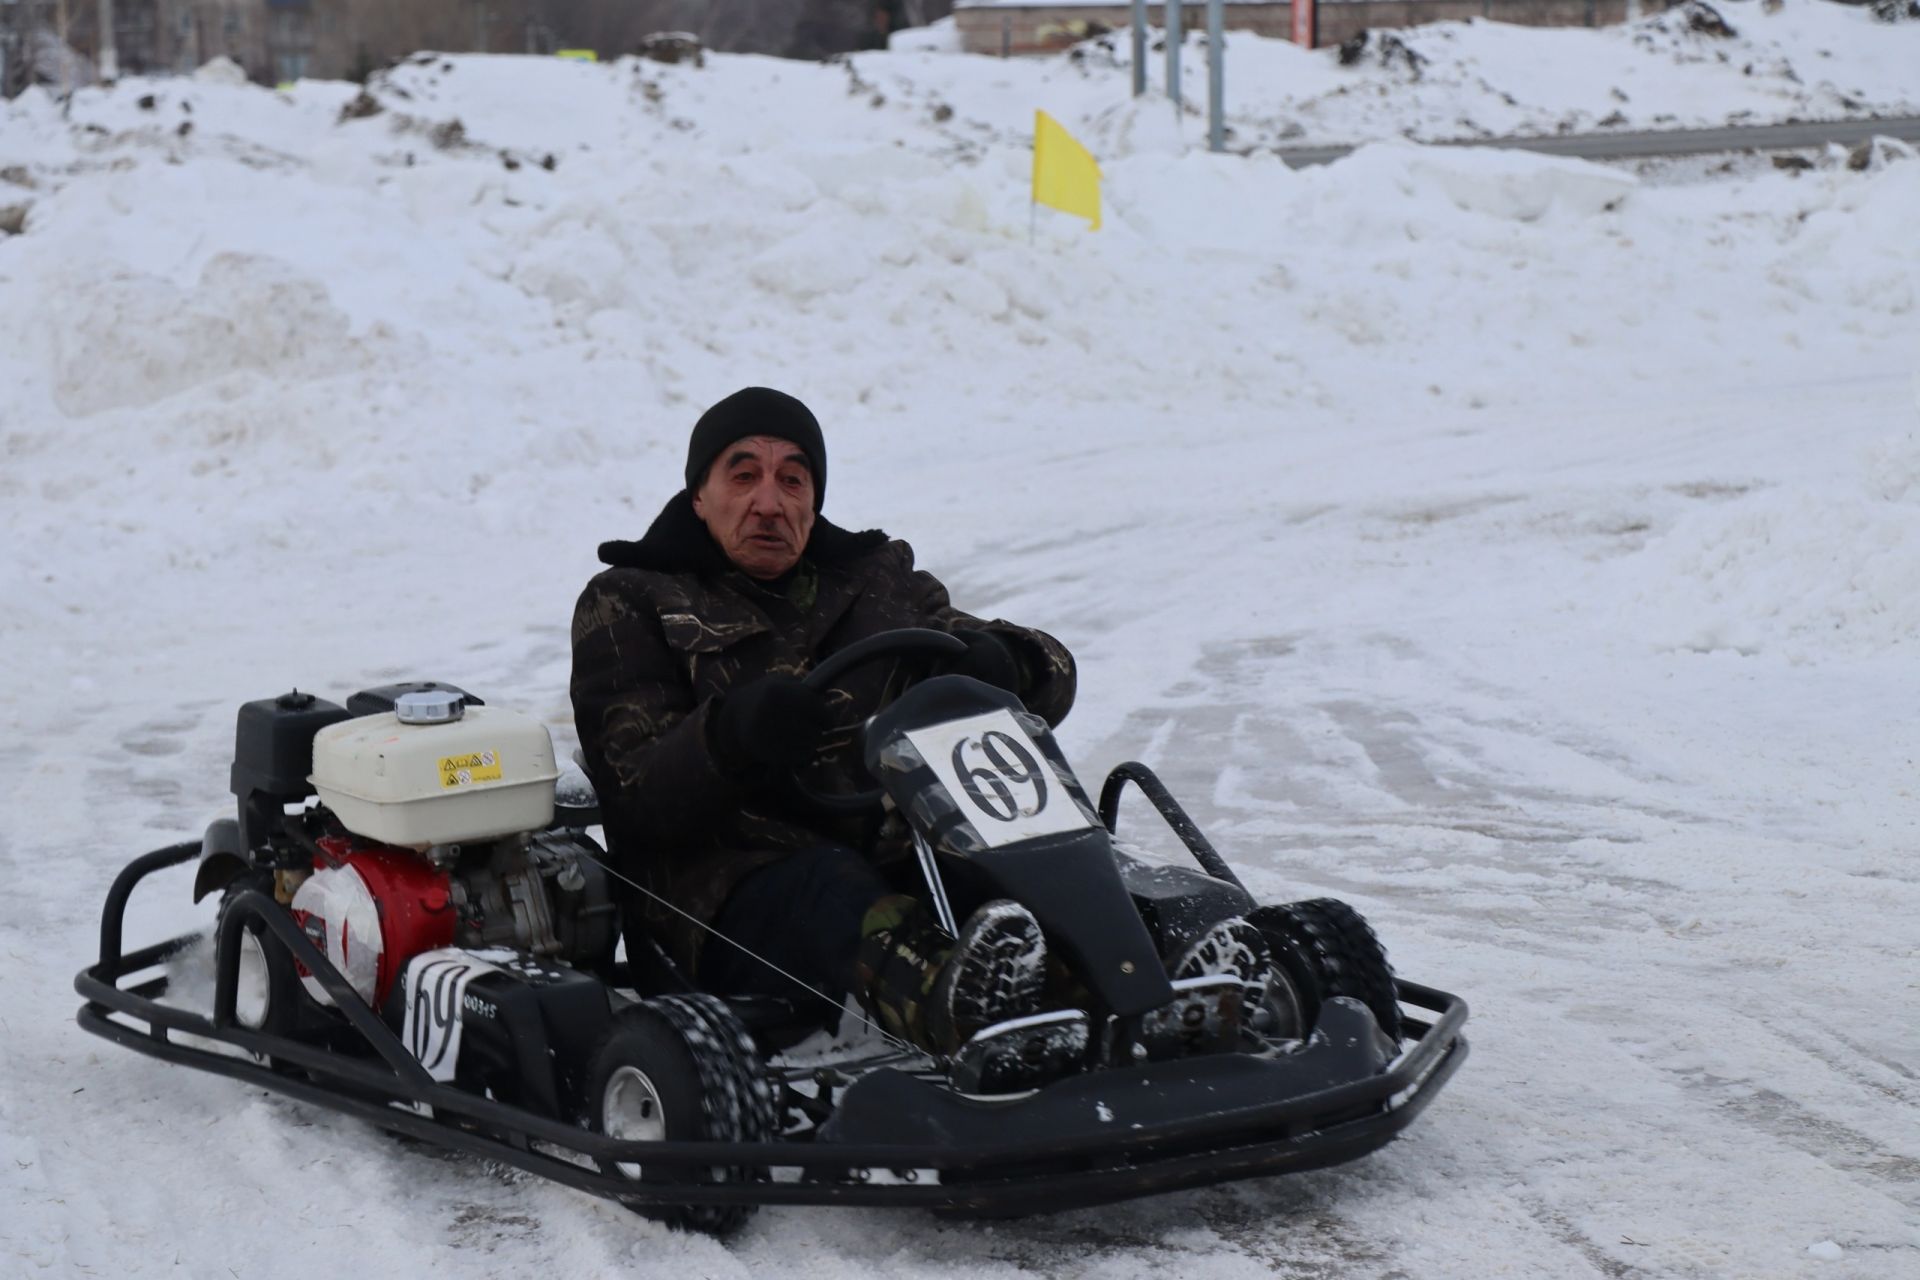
[0,0,1920,1280]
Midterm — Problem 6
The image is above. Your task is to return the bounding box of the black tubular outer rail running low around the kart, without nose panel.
[73,842,1467,1215]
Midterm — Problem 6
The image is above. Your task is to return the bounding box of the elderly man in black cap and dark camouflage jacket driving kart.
[572,388,1250,1054]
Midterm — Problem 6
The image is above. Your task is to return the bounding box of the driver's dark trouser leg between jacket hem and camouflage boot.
[699,844,891,1021]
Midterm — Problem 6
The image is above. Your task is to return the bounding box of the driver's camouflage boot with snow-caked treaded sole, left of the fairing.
[856,898,1046,1055]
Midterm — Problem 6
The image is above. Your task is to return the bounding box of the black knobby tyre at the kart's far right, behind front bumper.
[1248,898,1400,1046]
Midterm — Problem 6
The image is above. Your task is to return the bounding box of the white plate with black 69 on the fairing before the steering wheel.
[906,710,1092,848]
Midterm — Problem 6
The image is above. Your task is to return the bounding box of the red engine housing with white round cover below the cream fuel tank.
[292,837,457,1007]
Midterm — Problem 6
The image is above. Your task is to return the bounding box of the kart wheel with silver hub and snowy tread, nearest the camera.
[586,996,774,1236]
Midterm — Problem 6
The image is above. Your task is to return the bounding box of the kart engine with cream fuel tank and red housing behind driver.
[220,683,618,1007]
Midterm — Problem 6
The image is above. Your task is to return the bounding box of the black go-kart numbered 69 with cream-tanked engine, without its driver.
[75,631,1467,1232]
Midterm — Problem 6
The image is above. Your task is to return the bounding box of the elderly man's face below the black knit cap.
[693,436,814,580]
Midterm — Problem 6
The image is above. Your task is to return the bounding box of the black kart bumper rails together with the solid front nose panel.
[75,842,1467,1217]
